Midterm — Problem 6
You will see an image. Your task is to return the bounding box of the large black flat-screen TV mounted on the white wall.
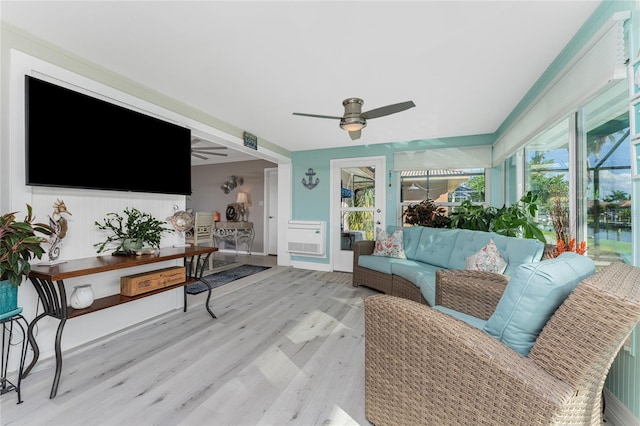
[25,76,191,195]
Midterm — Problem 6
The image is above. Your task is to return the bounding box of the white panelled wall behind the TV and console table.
[0,46,290,369]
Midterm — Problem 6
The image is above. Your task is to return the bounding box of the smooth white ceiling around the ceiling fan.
[0,0,600,164]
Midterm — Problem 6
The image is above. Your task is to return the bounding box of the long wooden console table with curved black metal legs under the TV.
[22,246,218,399]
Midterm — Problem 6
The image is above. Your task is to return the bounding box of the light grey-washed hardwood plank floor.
[0,253,375,425]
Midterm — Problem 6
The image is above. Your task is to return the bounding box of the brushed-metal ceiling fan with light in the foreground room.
[293,98,416,140]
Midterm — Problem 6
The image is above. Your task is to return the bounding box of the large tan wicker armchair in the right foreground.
[365,262,640,426]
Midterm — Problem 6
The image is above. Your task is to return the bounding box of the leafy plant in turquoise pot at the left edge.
[0,204,53,315]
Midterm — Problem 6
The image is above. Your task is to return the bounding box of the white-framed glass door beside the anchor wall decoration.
[330,157,385,272]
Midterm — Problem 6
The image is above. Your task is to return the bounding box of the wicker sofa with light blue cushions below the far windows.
[353,226,544,306]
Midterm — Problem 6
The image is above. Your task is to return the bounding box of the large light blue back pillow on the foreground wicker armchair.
[483,252,595,356]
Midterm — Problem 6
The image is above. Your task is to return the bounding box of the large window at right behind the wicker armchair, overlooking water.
[520,81,632,266]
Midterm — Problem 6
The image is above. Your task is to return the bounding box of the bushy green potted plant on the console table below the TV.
[93,208,174,254]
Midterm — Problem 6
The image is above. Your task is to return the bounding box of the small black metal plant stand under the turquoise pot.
[0,308,29,404]
